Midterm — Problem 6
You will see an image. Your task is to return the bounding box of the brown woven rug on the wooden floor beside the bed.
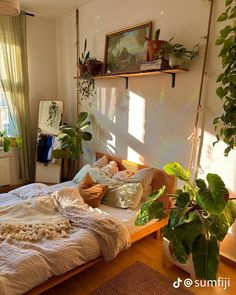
[90,261,193,295]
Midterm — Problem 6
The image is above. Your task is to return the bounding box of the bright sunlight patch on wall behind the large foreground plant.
[199,131,236,196]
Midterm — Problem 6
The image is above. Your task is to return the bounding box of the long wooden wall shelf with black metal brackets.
[93,67,188,89]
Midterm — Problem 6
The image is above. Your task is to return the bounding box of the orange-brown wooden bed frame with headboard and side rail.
[26,153,175,295]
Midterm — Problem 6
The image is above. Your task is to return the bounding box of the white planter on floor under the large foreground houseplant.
[162,238,196,280]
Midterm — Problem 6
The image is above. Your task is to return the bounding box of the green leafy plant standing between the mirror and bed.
[52,112,92,160]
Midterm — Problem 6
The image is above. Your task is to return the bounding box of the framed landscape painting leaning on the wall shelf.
[104,21,152,74]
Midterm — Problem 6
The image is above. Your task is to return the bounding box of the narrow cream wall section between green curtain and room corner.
[27,15,57,153]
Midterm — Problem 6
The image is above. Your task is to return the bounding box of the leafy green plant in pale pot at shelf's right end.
[161,38,199,67]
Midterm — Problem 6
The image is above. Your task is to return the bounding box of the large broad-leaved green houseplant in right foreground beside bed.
[136,162,236,280]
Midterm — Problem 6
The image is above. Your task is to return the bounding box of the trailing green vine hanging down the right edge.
[213,0,236,156]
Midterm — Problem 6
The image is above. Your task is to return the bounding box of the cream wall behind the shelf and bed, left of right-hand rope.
[57,0,209,167]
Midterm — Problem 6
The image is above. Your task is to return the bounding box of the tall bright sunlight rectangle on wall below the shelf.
[128,91,145,143]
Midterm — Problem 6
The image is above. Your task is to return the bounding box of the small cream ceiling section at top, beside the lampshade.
[20,0,92,17]
